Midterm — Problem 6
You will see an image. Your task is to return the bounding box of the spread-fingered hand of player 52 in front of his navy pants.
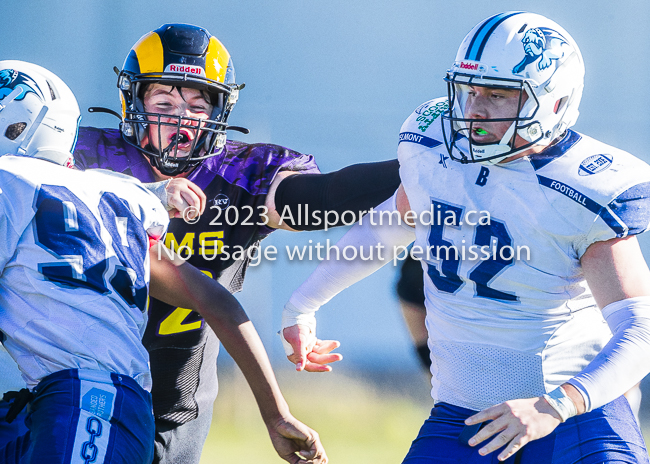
[465,397,562,461]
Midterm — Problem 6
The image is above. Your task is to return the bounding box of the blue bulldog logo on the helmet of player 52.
[512,27,569,74]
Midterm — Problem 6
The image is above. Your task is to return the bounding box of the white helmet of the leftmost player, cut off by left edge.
[0,60,81,167]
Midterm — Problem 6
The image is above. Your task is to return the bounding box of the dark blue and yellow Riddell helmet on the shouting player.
[117,24,243,175]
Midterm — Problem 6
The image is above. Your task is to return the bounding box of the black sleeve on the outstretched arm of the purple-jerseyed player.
[275,160,400,230]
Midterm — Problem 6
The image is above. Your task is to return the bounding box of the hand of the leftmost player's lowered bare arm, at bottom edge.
[269,416,328,464]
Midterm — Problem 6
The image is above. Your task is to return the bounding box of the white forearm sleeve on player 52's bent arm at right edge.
[568,296,650,412]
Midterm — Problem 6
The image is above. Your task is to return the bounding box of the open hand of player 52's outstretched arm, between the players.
[282,324,343,372]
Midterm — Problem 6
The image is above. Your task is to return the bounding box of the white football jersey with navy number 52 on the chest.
[398,98,650,410]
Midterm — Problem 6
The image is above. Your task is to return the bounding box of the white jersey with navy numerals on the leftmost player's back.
[0,155,169,389]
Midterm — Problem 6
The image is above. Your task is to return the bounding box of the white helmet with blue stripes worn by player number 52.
[442,11,585,164]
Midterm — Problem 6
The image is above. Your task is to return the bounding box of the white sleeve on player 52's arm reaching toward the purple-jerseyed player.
[282,195,415,330]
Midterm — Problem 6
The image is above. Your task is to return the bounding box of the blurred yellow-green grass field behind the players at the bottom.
[201,370,432,464]
